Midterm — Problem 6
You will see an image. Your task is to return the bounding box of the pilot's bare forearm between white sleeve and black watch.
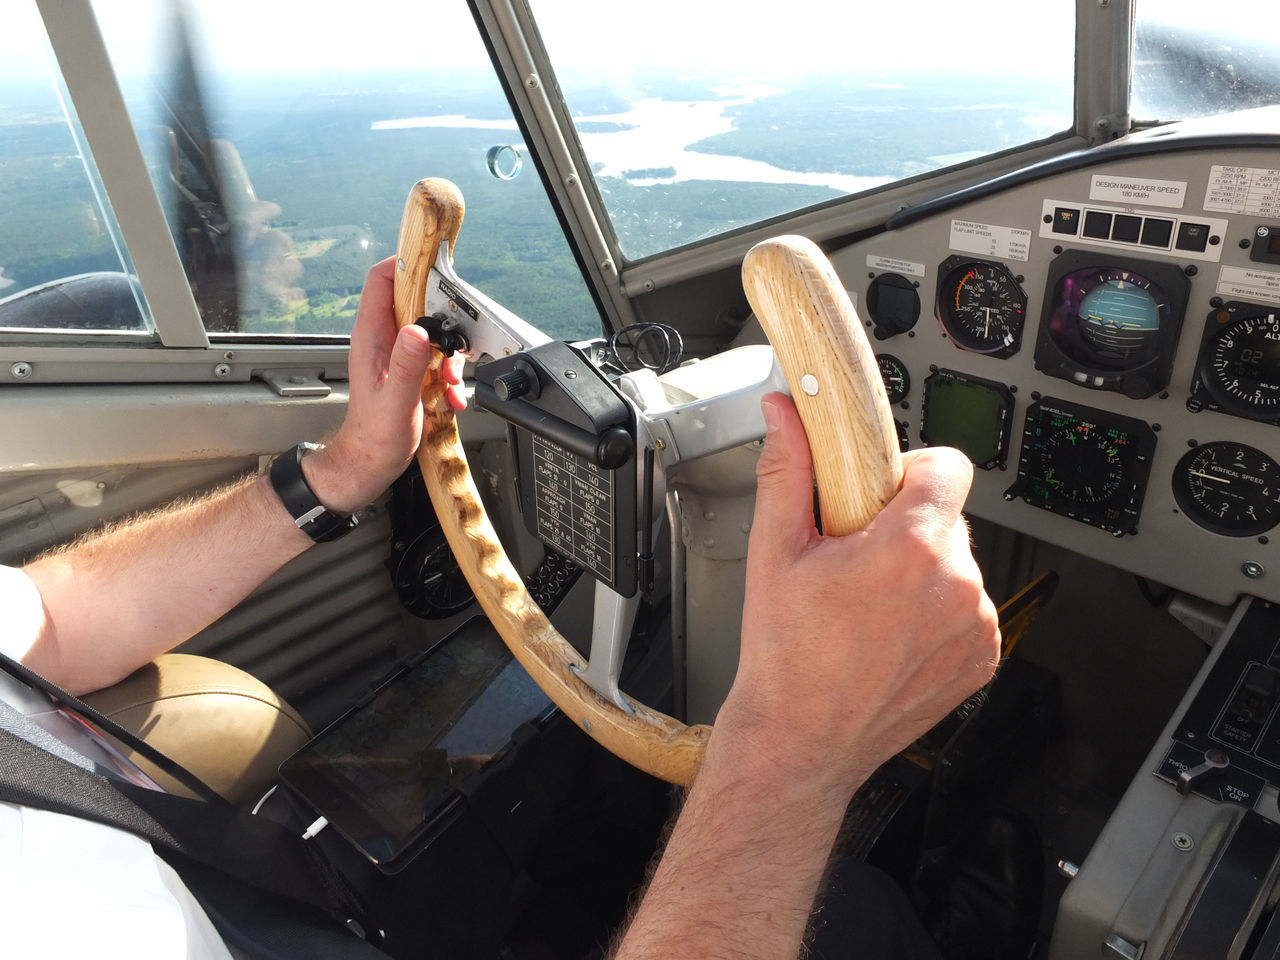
[23,471,319,692]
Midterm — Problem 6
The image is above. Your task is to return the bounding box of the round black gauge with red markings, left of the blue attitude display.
[938,257,1027,357]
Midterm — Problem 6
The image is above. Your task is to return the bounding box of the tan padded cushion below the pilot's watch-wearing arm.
[83,653,311,803]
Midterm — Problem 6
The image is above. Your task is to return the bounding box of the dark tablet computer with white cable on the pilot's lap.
[280,617,554,873]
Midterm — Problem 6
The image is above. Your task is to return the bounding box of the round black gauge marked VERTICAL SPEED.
[1174,440,1280,536]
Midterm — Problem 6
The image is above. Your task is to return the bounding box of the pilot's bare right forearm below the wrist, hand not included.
[614,708,870,960]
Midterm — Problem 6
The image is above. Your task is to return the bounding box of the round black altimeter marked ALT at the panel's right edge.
[1199,303,1280,420]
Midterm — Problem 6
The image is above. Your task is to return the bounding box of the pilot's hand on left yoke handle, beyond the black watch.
[302,257,466,513]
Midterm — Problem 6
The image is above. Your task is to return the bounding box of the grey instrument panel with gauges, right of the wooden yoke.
[832,145,1280,603]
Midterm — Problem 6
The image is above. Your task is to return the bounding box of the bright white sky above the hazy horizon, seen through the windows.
[0,0,1080,87]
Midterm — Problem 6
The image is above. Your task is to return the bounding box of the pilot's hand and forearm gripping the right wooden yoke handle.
[618,394,1000,960]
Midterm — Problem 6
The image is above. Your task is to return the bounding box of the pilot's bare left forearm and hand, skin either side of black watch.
[16,259,455,692]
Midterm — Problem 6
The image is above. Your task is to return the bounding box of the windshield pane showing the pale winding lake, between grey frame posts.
[530,0,1075,260]
